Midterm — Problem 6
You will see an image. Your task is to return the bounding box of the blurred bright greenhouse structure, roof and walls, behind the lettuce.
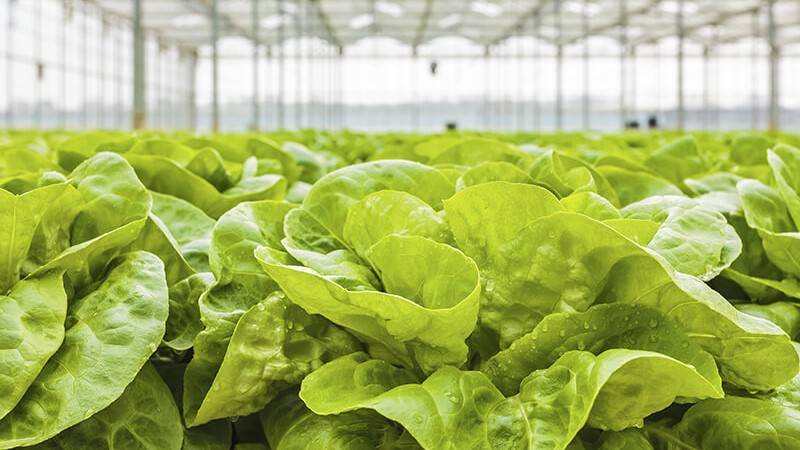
[0,0,800,131]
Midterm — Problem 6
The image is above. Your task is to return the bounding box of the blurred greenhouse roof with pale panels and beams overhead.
[94,0,800,48]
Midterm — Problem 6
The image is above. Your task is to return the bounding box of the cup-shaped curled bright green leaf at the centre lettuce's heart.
[256,235,480,372]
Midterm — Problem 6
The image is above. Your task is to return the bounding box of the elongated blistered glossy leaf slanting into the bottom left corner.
[0,252,168,448]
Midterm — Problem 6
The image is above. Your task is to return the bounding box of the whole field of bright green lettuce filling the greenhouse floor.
[0,130,800,450]
